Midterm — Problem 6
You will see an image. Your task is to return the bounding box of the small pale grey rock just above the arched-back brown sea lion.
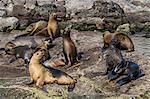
[116,23,132,34]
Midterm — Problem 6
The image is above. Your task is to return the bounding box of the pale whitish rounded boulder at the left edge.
[0,17,19,32]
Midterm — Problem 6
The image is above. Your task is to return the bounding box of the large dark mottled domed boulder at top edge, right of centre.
[76,1,124,17]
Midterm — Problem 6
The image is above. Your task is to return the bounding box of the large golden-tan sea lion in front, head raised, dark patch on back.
[29,50,77,91]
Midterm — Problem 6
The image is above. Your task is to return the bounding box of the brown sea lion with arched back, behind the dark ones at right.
[102,31,134,52]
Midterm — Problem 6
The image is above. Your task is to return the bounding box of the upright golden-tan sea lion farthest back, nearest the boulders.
[36,13,60,39]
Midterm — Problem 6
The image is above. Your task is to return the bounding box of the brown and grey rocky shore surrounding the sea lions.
[0,0,150,99]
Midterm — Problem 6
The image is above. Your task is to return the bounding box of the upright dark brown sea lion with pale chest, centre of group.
[63,27,78,66]
